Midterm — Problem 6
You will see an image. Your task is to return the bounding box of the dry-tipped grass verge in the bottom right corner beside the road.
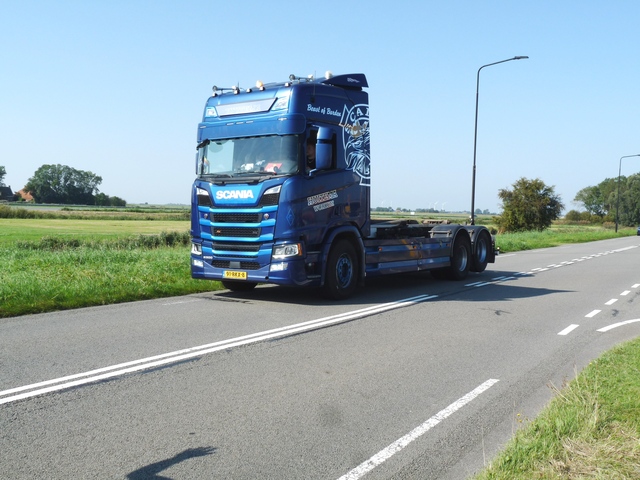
[474,339,640,480]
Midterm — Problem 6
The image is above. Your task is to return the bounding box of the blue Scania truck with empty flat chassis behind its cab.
[191,72,496,299]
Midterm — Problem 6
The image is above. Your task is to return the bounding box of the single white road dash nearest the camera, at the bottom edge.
[339,379,499,480]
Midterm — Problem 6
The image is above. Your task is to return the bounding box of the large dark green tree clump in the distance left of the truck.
[25,165,102,205]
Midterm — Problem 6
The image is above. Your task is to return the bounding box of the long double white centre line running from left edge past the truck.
[0,295,437,405]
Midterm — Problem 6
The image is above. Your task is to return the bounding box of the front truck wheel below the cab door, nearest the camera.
[323,240,358,300]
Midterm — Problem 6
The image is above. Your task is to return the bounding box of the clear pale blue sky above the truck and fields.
[0,0,640,211]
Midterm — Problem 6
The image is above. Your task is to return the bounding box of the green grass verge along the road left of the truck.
[0,232,221,318]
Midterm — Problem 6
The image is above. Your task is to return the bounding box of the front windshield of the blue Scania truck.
[197,135,299,178]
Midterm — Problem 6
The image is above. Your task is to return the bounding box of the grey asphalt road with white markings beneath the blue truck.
[0,237,640,480]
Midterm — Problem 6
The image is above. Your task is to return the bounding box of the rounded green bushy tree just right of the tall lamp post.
[495,177,564,232]
